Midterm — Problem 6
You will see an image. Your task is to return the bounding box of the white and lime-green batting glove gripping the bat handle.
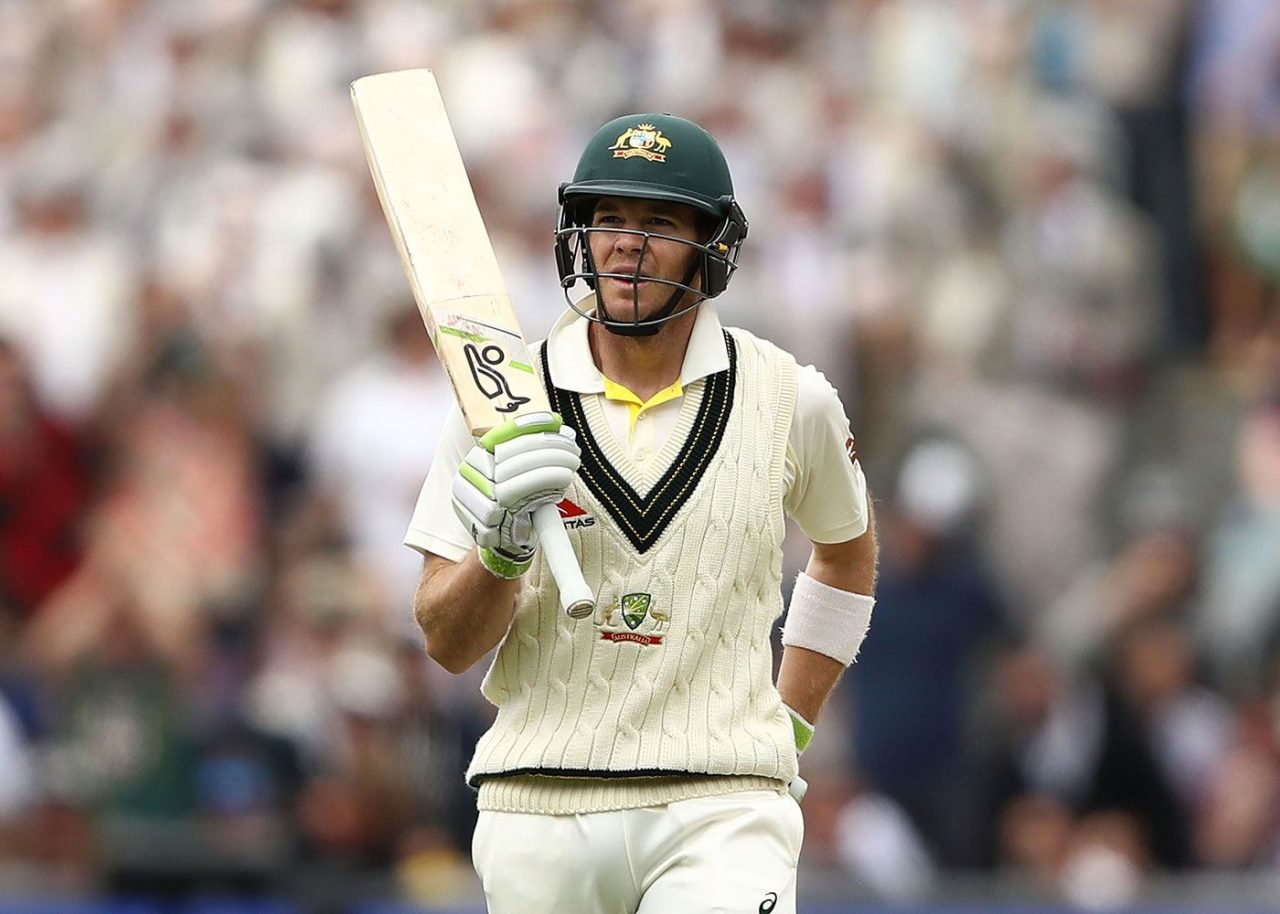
[452,412,581,577]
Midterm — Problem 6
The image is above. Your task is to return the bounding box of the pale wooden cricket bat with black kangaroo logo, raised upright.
[351,69,595,618]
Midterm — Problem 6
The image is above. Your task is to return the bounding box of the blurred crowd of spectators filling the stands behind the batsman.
[0,0,1280,910]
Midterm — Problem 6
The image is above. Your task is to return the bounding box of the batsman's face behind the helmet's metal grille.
[588,197,701,320]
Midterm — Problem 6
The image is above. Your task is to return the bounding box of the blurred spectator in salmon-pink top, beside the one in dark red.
[99,317,262,639]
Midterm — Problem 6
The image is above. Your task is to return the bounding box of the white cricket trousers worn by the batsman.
[471,790,804,914]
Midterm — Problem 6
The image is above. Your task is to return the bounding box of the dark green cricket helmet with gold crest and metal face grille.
[556,114,748,335]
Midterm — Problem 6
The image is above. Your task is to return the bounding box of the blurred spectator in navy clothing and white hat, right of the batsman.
[846,438,1005,865]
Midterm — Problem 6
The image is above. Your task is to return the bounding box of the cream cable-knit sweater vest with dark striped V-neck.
[467,330,796,792]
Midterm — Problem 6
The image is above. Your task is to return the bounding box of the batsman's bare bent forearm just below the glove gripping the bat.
[413,549,521,673]
